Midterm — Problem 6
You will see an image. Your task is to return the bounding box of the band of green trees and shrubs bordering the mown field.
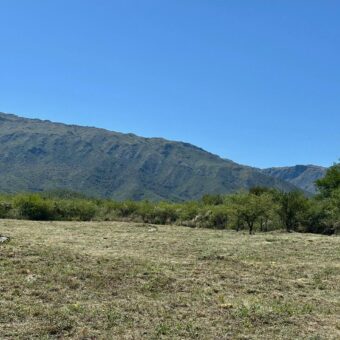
[0,164,340,235]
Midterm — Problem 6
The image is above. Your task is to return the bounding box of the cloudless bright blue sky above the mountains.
[0,0,340,167]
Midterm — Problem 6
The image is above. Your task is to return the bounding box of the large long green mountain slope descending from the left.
[0,113,295,201]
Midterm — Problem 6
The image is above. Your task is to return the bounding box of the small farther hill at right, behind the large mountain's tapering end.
[263,165,327,194]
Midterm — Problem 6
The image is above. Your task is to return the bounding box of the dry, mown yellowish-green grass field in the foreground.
[0,220,340,339]
